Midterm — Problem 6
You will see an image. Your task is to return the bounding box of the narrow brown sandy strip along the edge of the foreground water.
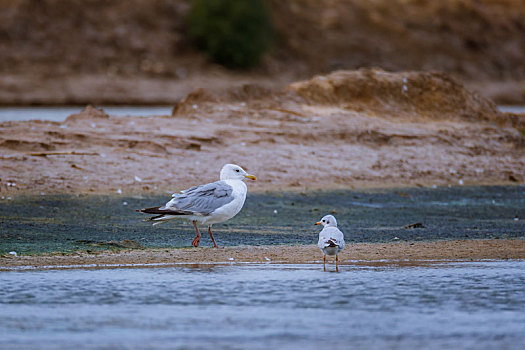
[0,239,525,270]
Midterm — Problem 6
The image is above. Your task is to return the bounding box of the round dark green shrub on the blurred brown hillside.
[188,0,272,68]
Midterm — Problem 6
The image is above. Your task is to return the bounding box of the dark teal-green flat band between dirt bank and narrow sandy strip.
[0,186,525,254]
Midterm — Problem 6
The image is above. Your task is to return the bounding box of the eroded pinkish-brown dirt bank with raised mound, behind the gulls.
[0,70,525,195]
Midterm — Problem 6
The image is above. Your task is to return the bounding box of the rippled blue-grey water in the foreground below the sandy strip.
[0,261,525,349]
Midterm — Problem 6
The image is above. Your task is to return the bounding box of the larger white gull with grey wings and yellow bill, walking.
[137,164,256,248]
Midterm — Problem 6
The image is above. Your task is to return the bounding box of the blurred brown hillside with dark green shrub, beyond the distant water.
[0,0,525,105]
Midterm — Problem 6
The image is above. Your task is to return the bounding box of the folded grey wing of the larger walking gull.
[160,181,233,215]
